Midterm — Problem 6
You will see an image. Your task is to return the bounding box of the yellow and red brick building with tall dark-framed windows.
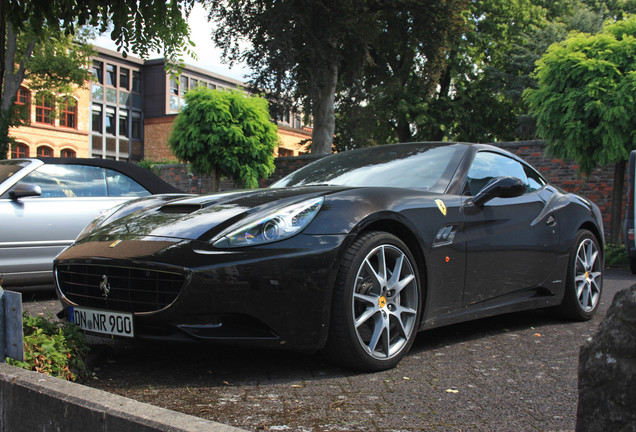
[9,47,311,162]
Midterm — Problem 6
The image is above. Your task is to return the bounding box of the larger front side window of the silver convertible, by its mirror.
[20,164,108,198]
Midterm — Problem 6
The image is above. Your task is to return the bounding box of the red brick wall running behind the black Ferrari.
[157,141,625,234]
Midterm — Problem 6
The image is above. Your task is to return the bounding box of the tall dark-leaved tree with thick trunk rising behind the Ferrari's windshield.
[204,0,375,153]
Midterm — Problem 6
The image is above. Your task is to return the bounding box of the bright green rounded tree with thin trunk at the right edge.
[525,15,636,243]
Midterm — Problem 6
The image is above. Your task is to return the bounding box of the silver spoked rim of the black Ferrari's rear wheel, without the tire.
[574,238,602,312]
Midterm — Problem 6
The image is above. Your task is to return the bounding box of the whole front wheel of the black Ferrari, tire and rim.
[325,231,422,371]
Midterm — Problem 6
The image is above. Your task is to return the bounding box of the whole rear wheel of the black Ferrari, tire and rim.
[560,230,603,321]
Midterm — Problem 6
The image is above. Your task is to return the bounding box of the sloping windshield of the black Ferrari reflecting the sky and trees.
[271,144,465,192]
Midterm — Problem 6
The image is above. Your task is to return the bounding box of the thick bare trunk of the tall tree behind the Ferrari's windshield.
[311,61,338,154]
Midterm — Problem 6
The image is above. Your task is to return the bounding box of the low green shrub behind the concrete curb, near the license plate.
[7,313,90,381]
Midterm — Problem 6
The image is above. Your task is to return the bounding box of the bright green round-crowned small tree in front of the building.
[168,87,279,191]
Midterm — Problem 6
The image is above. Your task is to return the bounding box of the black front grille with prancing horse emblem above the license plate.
[56,264,185,312]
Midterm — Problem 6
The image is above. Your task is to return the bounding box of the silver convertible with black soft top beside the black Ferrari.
[0,158,180,290]
